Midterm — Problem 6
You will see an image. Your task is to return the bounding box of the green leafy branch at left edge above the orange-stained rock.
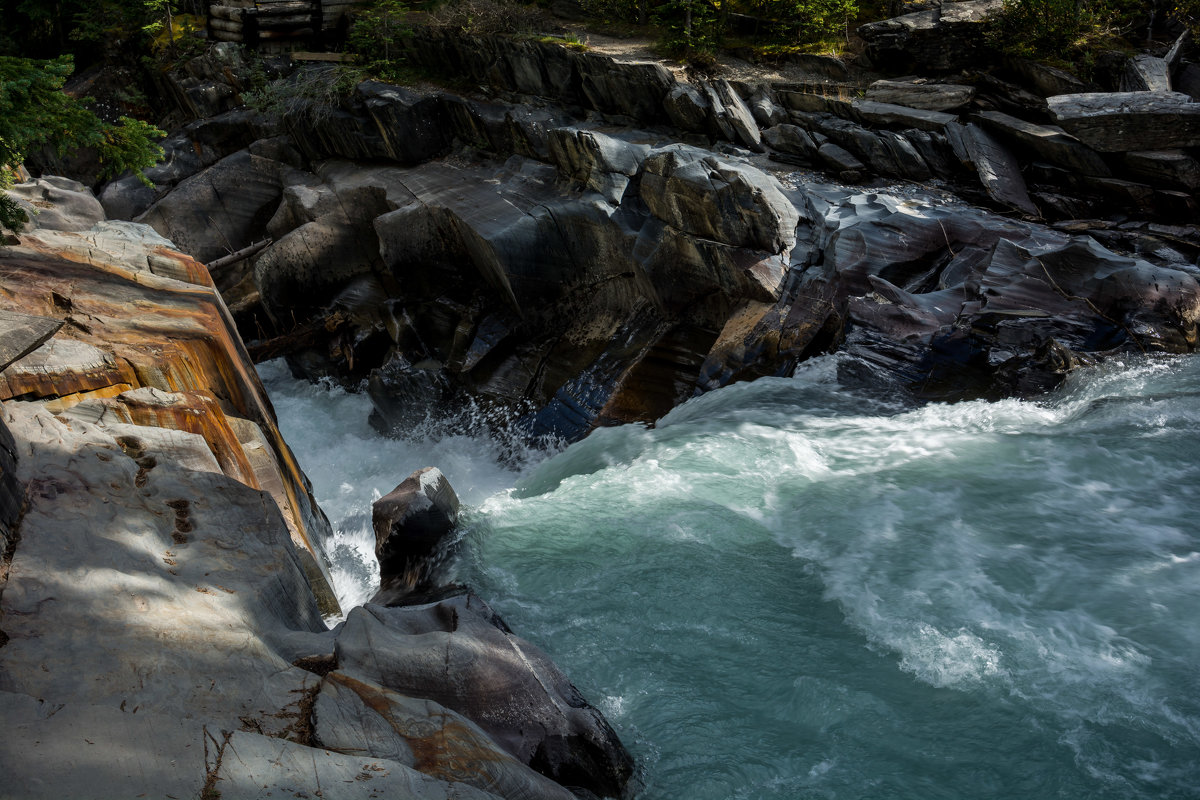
[0,55,164,228]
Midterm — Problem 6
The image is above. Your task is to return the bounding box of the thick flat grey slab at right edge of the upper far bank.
[1046,91,1200,152]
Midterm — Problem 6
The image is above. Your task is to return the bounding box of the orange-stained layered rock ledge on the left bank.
[0,223,337,613]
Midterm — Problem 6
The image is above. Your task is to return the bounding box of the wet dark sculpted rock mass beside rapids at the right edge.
[800,188,1200,399]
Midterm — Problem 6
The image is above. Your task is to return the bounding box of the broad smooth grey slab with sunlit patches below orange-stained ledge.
[0,402,325,730]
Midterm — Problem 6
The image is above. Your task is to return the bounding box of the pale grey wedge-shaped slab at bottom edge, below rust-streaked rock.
[212,730,496,800]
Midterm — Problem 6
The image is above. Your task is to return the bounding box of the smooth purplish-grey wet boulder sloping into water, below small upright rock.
[337,594,634,796]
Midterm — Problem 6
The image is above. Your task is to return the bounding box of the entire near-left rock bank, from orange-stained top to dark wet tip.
[0,181,632,800]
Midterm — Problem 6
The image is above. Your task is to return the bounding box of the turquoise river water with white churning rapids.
[264,356,1200,800]
